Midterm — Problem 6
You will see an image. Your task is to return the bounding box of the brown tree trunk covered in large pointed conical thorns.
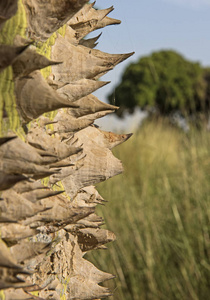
[0,0,132,300]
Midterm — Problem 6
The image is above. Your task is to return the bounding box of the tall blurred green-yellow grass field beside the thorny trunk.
[85,121,210,300]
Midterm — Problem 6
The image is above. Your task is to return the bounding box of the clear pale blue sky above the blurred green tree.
[92,0,210,131]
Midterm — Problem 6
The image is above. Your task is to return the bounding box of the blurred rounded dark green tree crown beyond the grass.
[108,51,210,116]
